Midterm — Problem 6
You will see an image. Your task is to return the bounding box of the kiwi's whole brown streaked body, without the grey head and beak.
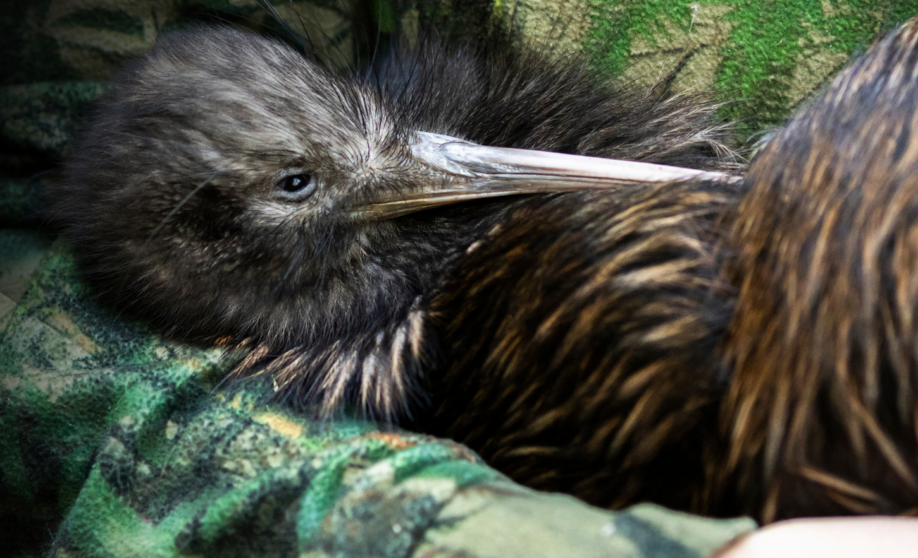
[430,20,918,522]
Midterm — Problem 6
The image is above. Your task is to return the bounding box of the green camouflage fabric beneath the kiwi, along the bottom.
[0,237,753,558]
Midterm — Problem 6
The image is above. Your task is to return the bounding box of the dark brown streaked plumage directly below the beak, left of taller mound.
[431,183,738,508]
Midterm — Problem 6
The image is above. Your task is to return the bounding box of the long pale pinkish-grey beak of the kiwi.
[351,132,742,219]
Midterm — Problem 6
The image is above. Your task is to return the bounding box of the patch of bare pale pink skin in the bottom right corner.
[712,517,918,558]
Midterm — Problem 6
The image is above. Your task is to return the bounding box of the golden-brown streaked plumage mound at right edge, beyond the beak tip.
[721,17,918,519]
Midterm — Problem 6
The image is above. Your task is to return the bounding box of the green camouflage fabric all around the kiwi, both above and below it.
[0,0,918,558]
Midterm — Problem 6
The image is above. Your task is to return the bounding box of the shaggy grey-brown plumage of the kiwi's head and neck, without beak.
[53,23,732,419]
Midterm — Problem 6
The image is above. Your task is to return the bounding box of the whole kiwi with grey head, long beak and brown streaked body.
[51,5,916,520]
